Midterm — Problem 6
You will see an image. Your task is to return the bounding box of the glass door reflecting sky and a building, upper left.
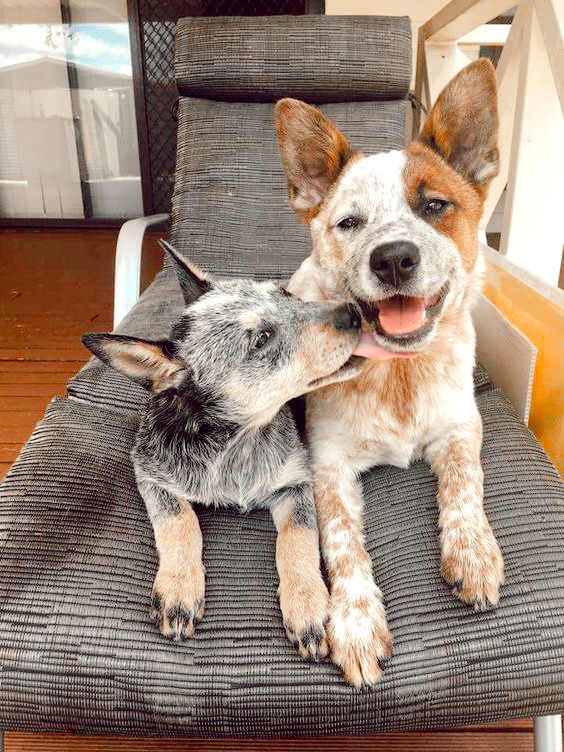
[0,0,143,220]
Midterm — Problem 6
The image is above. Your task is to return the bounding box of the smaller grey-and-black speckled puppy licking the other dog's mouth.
[82,243,363,660]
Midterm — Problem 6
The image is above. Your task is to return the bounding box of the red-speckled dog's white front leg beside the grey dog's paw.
[314,465,392,687]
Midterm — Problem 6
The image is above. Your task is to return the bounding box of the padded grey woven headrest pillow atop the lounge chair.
[175,16,411,102]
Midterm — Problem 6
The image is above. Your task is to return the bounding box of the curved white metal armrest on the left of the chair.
[114,214,170,328]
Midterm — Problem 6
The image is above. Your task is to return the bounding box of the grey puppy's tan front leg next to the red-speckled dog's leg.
[272,483,329,660]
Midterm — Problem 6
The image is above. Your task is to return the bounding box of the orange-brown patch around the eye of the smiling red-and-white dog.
[404,143,483,272]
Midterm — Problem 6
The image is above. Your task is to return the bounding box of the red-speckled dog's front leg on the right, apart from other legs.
[426,415,504,610]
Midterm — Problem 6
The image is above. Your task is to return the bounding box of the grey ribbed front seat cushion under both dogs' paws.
[0,389,564,736]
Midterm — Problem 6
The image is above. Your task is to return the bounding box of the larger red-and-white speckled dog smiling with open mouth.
[276,60,504,686]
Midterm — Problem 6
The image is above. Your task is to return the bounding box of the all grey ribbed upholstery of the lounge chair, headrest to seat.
[0,11,564,736]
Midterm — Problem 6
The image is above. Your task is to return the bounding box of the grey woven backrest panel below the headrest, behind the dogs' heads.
[171,98,406,278]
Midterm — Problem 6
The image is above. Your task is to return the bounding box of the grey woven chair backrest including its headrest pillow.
[171,16,411,278]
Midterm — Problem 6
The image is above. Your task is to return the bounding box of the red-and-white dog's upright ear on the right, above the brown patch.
[419,58,499,190]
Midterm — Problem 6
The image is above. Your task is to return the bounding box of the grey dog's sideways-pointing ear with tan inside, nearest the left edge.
[81,334,186,392]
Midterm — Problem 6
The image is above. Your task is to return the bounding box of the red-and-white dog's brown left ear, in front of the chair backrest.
[275,99,353,222]
